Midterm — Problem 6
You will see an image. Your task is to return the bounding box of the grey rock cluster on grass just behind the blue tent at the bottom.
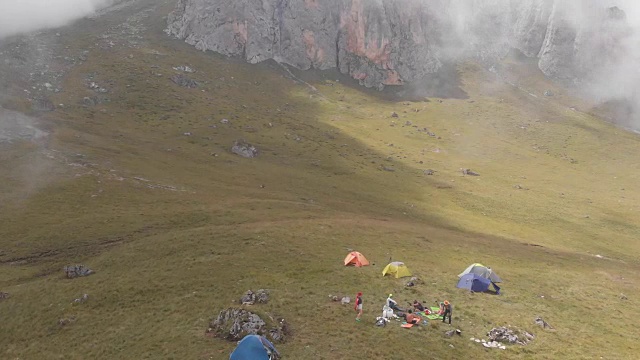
[207,308,290,342]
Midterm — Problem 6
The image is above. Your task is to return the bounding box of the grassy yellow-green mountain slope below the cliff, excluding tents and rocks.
[0,1,640,359]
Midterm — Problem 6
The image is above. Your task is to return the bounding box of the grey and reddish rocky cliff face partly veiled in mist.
[167,0,628,89]
